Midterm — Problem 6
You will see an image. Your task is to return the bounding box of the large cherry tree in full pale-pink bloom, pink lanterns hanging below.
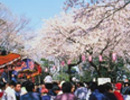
[36,1,130,81]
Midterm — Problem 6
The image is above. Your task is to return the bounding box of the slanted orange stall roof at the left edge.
[0,53,20,68]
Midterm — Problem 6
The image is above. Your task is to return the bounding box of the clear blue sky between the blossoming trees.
[1,0,65,29]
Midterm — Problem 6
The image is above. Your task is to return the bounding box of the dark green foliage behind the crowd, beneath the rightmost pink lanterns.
[93,57,129,81]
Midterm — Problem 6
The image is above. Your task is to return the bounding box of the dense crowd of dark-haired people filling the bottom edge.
[0,75,130,100]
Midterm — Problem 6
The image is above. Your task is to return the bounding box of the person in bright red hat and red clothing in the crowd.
[114,83,124,100]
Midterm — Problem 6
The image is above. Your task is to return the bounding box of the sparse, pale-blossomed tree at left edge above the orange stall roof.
[0,4,28,53]
